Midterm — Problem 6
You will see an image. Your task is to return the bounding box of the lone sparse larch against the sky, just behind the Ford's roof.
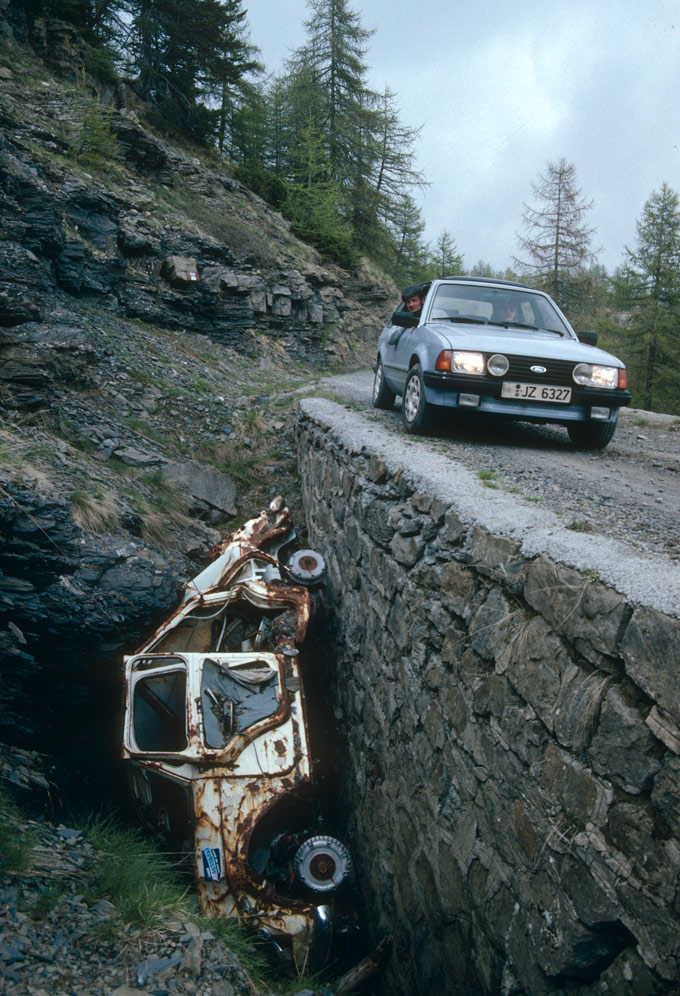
[514,159,595,307]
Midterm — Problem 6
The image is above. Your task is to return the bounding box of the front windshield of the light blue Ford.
[429,284,571,335]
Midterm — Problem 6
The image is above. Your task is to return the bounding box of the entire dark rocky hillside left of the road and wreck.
[0,23,394,796]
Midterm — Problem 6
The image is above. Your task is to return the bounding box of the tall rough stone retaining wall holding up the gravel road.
[298,402,680,996]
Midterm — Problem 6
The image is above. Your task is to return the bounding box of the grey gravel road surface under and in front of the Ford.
[322,371,680,562]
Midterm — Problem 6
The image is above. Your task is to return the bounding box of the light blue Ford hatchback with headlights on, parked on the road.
[373,277,631,449]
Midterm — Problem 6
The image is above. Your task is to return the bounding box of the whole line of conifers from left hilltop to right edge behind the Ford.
[7,0,680,404]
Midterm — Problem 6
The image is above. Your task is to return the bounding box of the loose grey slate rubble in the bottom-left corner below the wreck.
[0,820,262,996]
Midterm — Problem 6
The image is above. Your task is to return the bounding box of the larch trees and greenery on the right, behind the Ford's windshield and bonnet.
[512,159,680,415]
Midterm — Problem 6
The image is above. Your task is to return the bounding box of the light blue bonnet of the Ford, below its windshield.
[430,322,623,367]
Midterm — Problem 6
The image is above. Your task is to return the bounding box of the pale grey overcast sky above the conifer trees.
[243,0,680,271]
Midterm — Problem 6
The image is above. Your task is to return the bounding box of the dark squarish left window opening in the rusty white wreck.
[133,670,188,753]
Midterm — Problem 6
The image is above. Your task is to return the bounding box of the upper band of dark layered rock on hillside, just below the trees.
[0,26,394,364]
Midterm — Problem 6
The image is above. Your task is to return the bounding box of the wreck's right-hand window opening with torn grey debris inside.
[201,658,279,750]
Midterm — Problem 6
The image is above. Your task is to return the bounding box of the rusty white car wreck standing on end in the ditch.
[123,498,358,969]
